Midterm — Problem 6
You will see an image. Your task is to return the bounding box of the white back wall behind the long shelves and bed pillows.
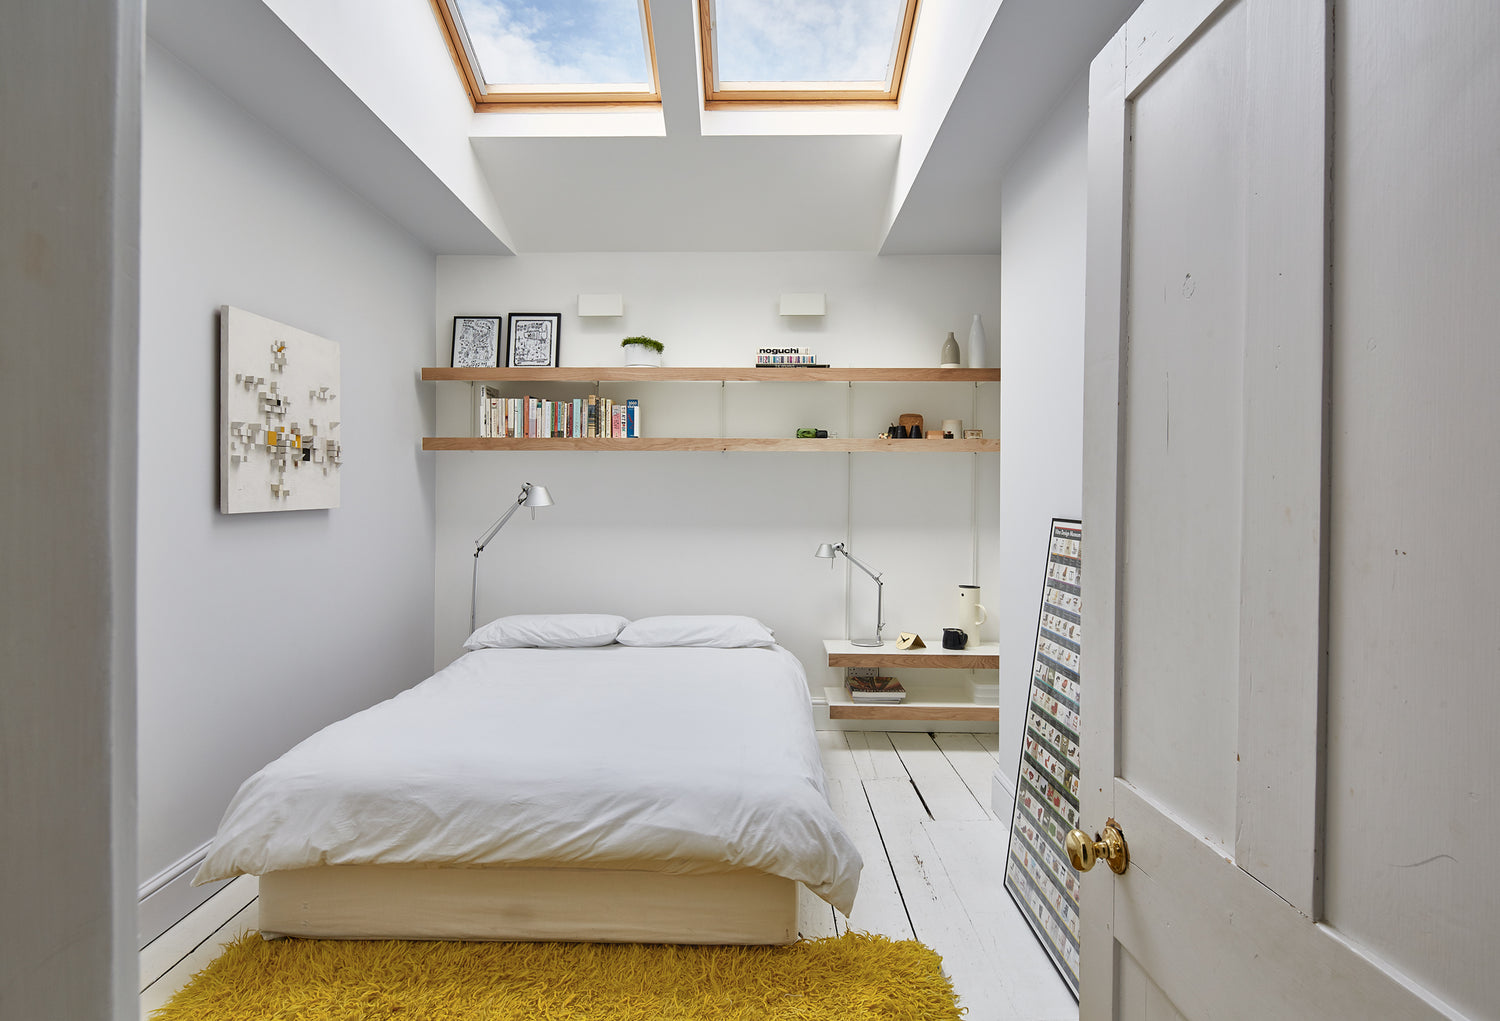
[432,252,999,716]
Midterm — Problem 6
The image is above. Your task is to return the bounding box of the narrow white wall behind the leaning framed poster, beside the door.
[989,75,1089,784]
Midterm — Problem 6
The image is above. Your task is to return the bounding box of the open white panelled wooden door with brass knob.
[1080,0,1500,1021]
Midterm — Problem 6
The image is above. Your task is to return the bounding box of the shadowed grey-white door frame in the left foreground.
[0,0,141,1020]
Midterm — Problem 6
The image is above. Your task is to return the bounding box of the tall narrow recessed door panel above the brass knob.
[1118,3,1245,847]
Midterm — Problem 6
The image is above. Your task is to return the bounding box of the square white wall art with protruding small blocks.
[219,306,344,514]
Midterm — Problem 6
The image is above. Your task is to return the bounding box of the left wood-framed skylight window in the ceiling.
[434,0,660,106]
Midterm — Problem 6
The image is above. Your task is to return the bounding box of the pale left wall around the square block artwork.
[133,43,435,936]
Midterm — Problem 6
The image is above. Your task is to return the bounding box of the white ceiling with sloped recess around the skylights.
[149,0,1139,253]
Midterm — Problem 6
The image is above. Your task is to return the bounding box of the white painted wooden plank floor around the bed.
[141,730,1079,1021]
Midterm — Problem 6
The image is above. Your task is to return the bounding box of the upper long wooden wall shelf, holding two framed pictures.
[422,366,1001,382]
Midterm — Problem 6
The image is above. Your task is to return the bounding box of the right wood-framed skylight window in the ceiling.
[699,0,917,102]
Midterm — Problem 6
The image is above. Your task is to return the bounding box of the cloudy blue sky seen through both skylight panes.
[456,0,905,84]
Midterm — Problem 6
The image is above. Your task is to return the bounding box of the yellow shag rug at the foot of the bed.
[152,933,963,1021]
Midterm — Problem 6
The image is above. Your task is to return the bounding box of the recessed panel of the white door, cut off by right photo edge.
[1325,0,1500,1018]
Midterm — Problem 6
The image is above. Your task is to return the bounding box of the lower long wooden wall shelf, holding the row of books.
[422,436,1001,454]
